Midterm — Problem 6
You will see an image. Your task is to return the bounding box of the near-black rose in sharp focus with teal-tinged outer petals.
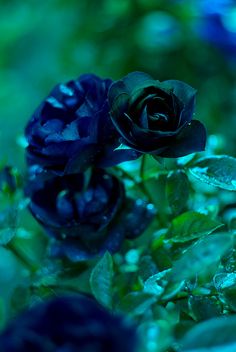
[109,72,206,158]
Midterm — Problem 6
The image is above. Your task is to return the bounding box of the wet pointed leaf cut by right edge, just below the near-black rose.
[189,155,236,191]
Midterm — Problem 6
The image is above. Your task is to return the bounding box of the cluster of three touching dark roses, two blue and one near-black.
[25,72,206,261]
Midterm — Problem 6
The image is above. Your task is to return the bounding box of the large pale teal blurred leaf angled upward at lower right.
[171,233,232,282]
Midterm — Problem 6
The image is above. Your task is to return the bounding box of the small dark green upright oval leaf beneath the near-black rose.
[166,170,189,215]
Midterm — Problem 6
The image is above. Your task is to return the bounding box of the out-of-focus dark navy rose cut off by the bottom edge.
[0,295,137,352]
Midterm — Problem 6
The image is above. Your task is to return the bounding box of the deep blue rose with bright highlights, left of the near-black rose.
[25,74,140,175]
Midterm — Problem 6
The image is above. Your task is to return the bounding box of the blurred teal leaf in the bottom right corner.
[181,316,236,352]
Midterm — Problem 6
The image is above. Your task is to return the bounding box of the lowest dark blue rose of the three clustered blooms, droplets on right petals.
[27,169,154,261]
